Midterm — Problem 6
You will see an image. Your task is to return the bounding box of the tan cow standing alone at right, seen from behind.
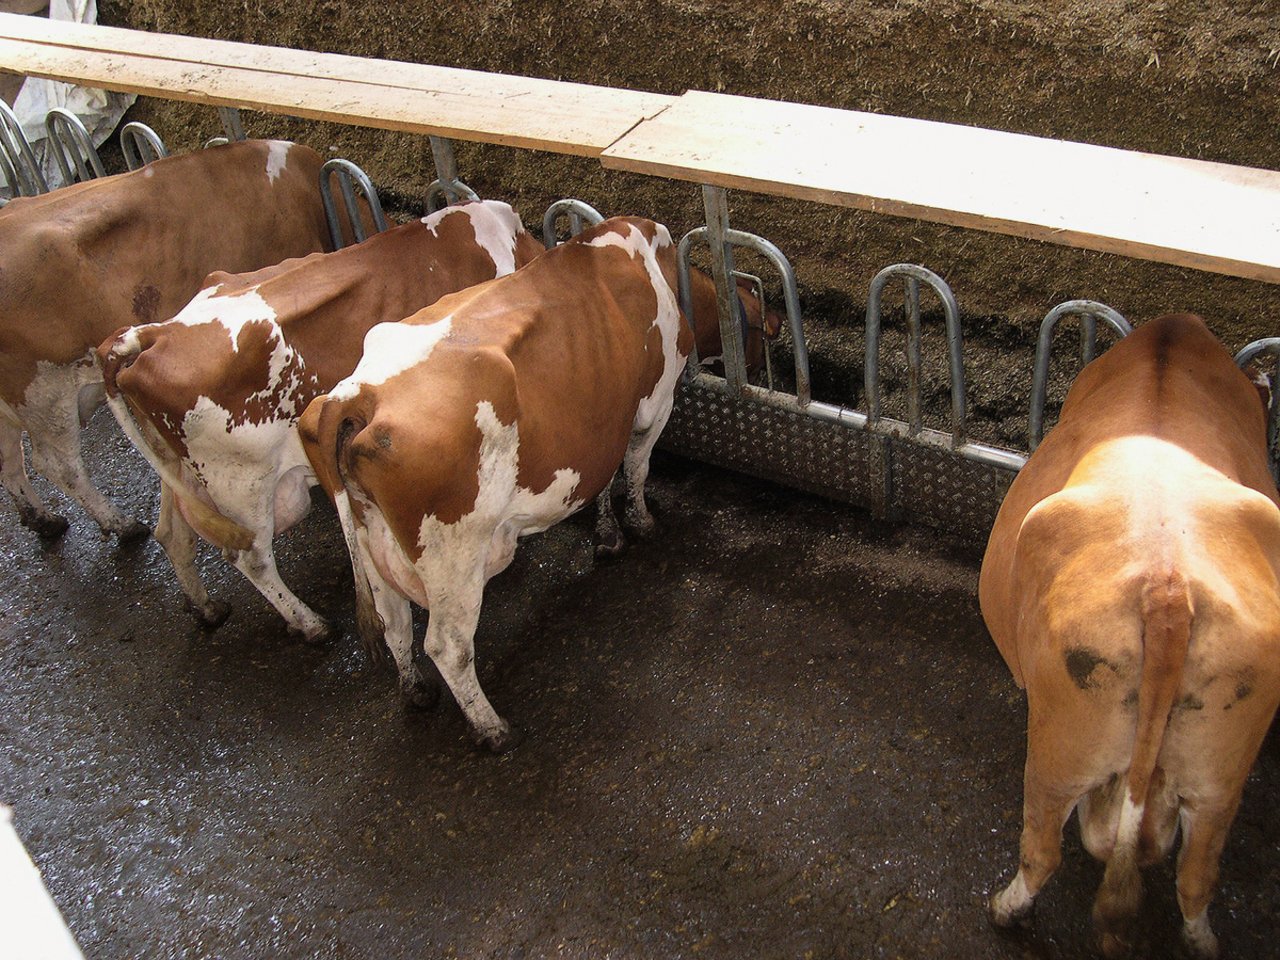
[979,315,1280,956]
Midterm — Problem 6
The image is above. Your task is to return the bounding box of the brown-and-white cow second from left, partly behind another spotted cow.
[99,201,543,640]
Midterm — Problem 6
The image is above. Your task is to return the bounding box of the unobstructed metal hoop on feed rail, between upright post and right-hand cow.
[863,264,969,447]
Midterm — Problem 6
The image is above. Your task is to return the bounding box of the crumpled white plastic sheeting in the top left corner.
[13,0,136,189]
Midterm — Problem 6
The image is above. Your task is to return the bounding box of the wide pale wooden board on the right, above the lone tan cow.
[600,92,1280,283]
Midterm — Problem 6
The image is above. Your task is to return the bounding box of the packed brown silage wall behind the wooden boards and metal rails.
[100,0,1280,447]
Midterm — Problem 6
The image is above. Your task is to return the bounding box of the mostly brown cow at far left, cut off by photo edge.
[0,141,329,539]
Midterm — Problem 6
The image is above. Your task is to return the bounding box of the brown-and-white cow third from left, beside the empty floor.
[300,218,714,750]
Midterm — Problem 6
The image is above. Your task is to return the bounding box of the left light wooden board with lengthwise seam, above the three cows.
[0,14,675,156]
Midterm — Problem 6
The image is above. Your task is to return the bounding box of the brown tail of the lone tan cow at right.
[1093,571,1192,956]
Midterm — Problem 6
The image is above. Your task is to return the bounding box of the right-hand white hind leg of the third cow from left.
[424,560,518,753]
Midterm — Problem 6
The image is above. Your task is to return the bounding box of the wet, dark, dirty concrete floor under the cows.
[0,415,1280,960]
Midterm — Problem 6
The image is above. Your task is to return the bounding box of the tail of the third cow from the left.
[314,398,390,663]
